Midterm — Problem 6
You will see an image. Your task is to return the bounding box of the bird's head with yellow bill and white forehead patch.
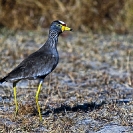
[50,20,72,33]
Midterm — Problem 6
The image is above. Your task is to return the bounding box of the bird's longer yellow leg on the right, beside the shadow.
[36,79,43,121]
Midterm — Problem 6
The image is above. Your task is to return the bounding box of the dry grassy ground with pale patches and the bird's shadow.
[0,29,133,133]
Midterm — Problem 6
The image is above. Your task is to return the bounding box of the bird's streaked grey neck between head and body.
[46,30,59,48]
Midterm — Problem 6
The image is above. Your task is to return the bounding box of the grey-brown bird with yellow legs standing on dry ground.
[0,20,72,121]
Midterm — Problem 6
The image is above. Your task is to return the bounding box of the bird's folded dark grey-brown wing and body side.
[6,51,58,81]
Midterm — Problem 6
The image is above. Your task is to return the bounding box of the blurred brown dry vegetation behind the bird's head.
[0,0,133,34]
